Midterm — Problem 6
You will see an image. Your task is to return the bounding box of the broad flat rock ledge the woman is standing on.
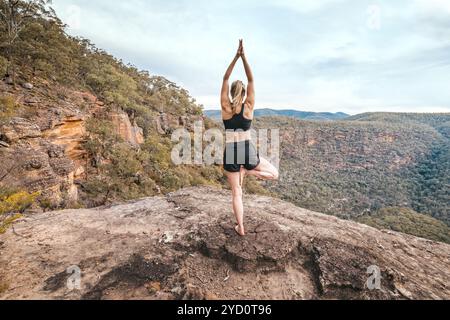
[0,187,450,299]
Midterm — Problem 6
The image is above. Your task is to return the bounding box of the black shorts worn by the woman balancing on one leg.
[223,141,261,172]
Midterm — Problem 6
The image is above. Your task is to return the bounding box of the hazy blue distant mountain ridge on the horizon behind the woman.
[203,109,350,121]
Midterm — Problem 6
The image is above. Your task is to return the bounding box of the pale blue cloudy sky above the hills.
[53,0,450,114]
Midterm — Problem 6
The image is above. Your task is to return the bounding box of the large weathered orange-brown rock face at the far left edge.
[0,81,108,206]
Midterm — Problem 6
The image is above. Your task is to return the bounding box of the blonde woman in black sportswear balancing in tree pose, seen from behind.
[221,40,278,236]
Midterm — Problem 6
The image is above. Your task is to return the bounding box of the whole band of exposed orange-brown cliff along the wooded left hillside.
[0,80,201,208]
